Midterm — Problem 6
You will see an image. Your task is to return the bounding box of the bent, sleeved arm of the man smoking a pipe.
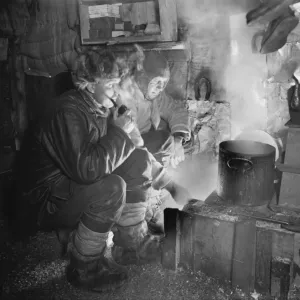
[43,109,135,184]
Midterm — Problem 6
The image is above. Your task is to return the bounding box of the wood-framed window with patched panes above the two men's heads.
[79,0,178,45]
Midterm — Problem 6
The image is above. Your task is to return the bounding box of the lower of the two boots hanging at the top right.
[260,15,299,54]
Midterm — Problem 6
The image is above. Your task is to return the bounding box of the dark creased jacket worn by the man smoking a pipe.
[18,90,135,199]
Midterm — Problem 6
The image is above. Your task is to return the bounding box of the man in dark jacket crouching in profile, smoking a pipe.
[16,51,193,291]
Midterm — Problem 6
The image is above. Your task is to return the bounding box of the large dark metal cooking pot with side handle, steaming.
[217,140,275,206]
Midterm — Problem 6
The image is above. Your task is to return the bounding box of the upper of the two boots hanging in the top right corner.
[246,0,299,26]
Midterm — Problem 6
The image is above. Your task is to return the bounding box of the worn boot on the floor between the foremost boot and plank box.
[112,221,162,265]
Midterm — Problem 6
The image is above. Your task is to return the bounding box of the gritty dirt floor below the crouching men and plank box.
[0,218,300,300]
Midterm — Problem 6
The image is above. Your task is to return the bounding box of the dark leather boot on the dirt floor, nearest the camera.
[67,238,128,292]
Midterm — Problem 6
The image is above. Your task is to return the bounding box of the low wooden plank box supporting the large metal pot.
[162,203,300,300]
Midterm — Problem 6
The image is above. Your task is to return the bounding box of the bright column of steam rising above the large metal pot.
[223,14,267,138]
